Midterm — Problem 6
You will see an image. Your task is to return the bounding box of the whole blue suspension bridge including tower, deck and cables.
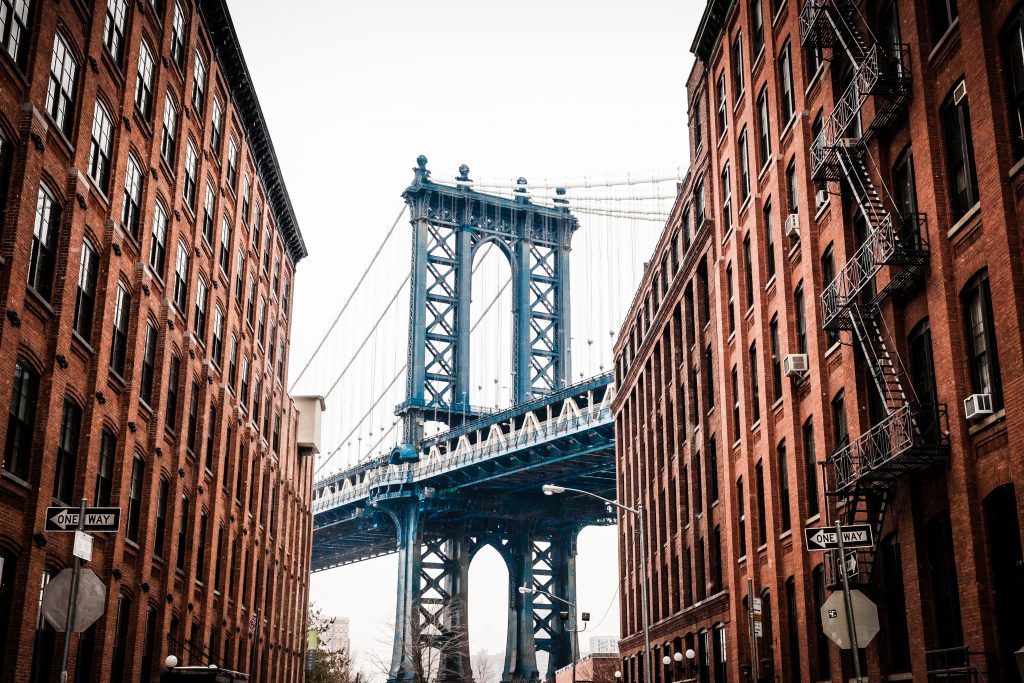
[291,157,681,681]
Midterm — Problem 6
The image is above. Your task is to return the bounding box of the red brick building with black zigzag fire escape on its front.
[615,0,1024,683]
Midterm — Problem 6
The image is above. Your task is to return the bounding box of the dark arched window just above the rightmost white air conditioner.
[961,270,1002,411]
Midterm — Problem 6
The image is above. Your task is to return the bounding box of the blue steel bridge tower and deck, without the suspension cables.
[312,162,615,683]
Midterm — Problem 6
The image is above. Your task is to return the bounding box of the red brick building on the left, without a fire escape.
[0,0,311,683]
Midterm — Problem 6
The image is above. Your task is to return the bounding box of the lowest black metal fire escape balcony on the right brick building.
[827,403,949,495]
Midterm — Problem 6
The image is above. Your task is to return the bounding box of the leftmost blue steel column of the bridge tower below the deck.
[388,500,422,683]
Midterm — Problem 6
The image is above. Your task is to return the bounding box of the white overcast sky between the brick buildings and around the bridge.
[229,0,703,671]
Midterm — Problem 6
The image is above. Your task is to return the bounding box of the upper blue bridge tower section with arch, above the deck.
[396,156,579,449]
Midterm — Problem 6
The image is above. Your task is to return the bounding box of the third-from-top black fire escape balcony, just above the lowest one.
[821,213,928,330]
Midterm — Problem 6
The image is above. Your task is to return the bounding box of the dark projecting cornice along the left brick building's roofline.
[198,0,308,263]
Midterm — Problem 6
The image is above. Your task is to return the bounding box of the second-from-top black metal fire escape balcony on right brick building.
[804,43,910,180]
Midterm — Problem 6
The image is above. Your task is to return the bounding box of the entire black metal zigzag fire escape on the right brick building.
[800,0,947,585]
